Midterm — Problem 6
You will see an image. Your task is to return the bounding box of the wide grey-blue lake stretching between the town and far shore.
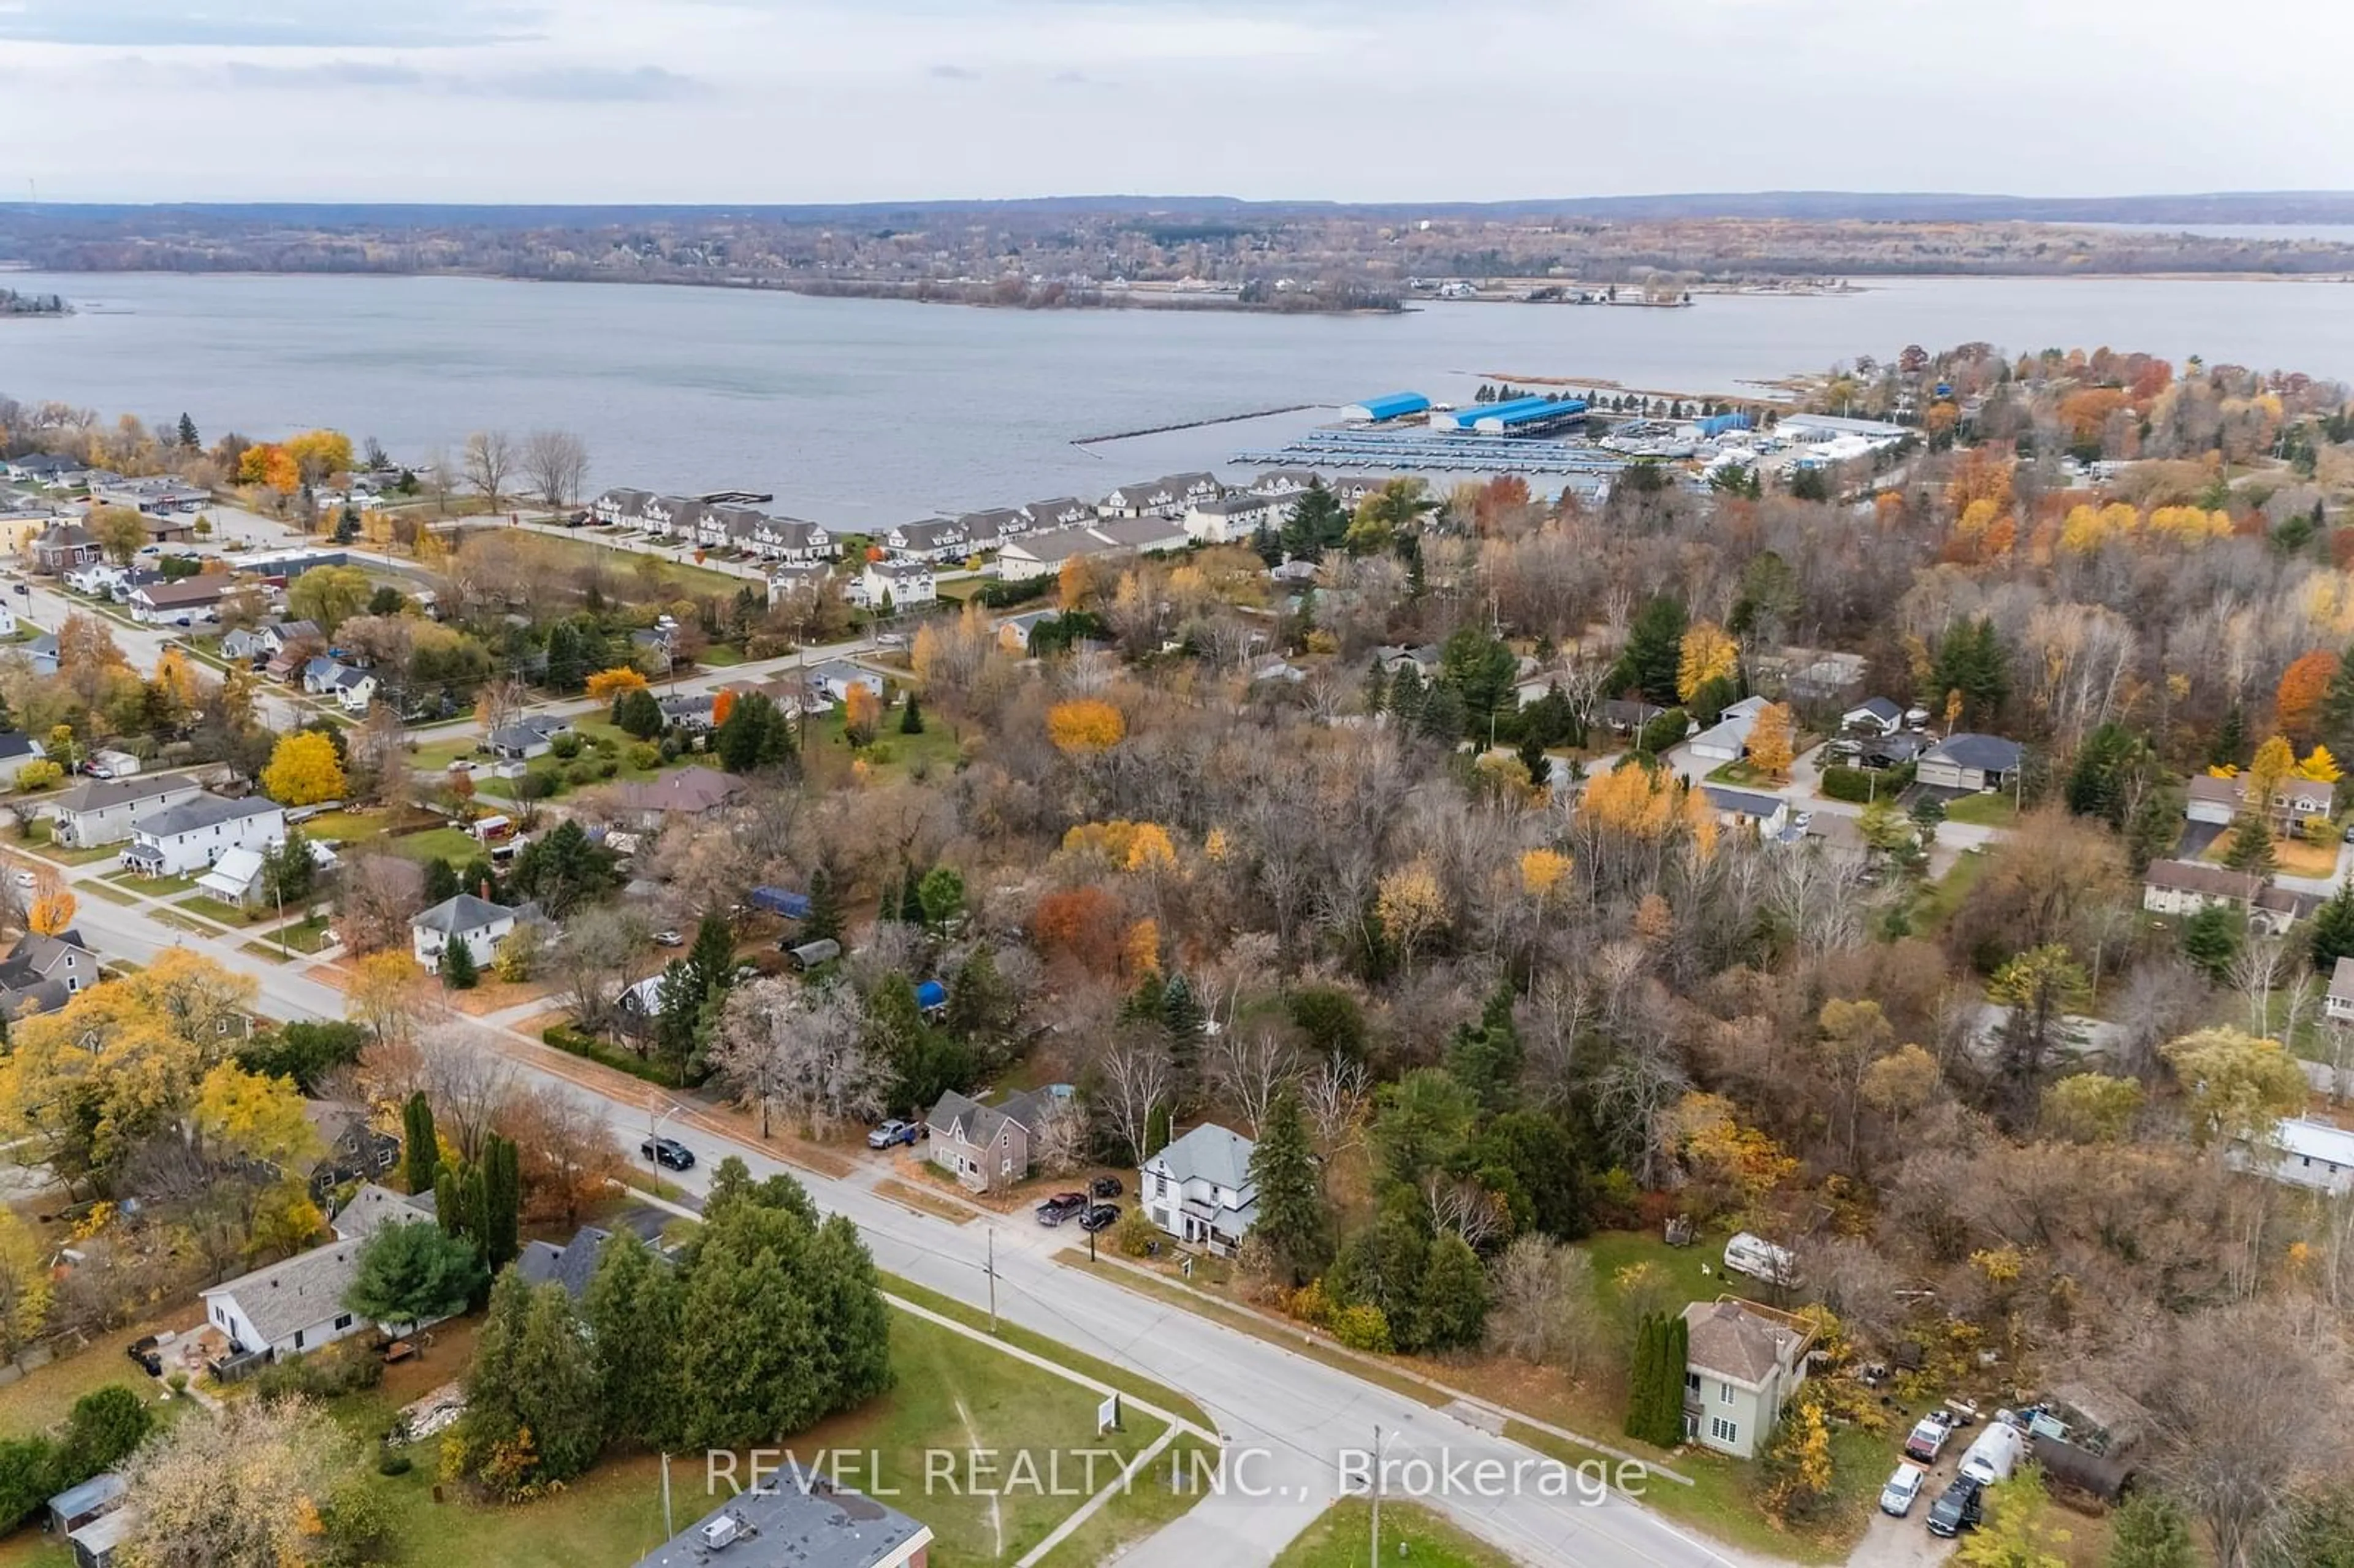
[0,273,2354,527]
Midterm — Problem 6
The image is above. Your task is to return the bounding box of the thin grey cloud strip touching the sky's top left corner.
[0,0,544,50]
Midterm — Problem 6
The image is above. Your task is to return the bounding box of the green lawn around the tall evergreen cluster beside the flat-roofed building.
[334,1314,1160,1568]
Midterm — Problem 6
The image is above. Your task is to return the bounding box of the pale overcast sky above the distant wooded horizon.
[0,0,2354,202]
